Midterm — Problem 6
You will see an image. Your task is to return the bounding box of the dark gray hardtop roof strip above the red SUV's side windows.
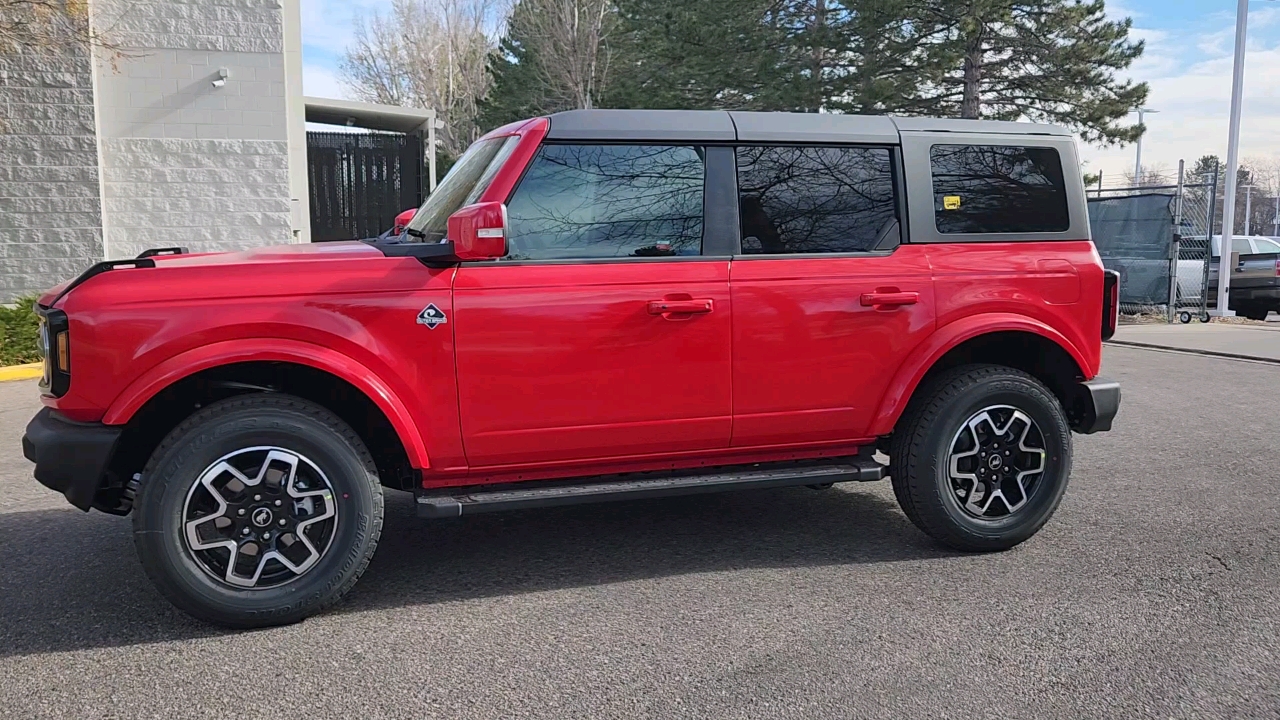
[547,110,1071,145]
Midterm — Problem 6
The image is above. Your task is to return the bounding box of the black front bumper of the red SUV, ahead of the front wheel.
[22,407,123,510]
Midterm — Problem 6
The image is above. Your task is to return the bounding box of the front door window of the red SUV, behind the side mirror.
[507,145,704,260]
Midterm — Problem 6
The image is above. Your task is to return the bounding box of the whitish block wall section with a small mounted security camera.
[93,0,294,258]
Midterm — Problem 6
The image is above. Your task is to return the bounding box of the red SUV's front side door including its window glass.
[453,145,732,468]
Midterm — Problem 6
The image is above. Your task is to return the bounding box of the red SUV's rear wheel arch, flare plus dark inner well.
[869,315,1092,436]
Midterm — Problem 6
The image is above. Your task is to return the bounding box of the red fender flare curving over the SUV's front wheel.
[102,338,430,469]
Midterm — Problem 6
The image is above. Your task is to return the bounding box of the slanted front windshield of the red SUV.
[404,136,520,242]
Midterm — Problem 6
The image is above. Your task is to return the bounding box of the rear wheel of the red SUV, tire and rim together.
[890,365,1071,551]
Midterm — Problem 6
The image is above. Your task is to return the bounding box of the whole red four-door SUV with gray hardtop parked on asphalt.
[23,110,1120,626]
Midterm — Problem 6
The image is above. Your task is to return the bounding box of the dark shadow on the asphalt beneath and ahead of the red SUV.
[0,488,948,657]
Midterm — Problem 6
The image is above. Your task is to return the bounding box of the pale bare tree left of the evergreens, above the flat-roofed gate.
[339,0,502,156]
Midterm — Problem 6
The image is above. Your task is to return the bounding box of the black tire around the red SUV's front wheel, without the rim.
[133,395,383,628]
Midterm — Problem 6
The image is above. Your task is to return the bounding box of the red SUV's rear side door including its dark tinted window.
[731,145,933,447]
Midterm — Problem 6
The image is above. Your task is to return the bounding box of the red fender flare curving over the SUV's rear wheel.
[868,313,1089,436]
